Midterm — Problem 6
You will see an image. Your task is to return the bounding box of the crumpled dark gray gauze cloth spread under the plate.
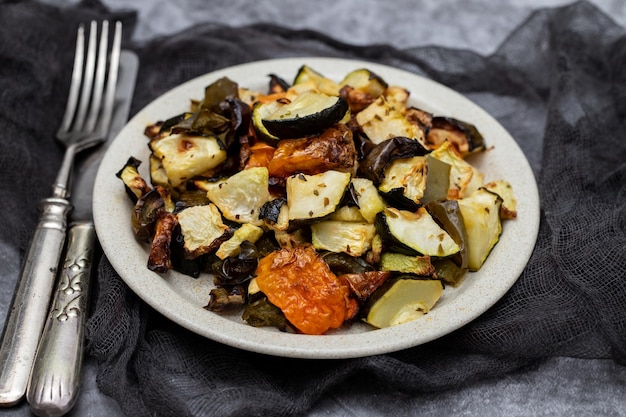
[0,1,626,416]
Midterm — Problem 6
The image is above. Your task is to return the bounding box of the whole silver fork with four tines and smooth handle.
[0,21,122,406]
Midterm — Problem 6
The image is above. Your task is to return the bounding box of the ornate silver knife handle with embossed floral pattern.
[26,222,96,417]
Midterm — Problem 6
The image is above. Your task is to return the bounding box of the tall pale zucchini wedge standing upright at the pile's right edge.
[459,188,502,271]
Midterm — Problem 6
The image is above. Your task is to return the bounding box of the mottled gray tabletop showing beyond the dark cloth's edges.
[0,0,626,417]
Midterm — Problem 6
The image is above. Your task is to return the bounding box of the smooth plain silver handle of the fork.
[0,197,72,406]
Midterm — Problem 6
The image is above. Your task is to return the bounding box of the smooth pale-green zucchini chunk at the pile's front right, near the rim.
[365,279,443,328]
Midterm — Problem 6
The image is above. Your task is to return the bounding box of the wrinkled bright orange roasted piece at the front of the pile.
[256,245,358,334]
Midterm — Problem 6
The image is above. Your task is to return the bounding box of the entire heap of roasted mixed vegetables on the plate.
[117,65,516,334]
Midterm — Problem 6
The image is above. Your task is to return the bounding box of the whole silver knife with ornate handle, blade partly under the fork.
[26,50,139,417]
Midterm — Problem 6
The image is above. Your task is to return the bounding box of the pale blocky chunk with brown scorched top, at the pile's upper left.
[150,134,227,187]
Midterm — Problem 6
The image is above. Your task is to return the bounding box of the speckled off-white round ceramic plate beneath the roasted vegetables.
[94,58,539,359]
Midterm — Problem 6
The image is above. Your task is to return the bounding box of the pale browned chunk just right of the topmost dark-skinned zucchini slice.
[356,96,424,144]
